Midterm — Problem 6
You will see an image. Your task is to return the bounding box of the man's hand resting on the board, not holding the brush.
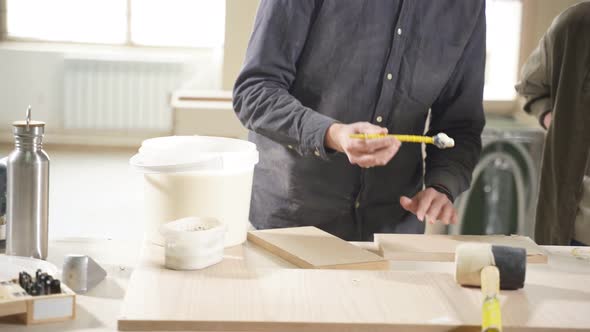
[399,188,458,225]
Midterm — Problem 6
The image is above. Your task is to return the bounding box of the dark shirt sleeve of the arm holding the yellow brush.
[233,0,336,159]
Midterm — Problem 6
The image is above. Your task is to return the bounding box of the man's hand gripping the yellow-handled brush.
[325,122,401,168]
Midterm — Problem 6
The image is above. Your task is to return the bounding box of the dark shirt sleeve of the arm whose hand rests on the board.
[425,6,486,198]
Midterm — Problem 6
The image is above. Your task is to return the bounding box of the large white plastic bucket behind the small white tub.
[130,136,258,247]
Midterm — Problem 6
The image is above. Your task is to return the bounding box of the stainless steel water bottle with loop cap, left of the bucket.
[6,106,49,259]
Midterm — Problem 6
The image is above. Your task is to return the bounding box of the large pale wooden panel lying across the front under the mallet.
[118,246,590,332]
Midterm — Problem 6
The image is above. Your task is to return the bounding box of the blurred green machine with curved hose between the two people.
[449,116,545,237]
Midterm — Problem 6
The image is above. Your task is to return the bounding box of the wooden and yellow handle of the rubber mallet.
[481,266,502,332]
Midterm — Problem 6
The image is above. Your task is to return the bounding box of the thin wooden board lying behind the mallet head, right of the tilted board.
[375,234,547,263]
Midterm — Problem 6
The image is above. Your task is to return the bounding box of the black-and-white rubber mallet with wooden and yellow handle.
[455,243,526,331]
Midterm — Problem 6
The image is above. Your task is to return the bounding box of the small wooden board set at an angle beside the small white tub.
[248,227,389,270]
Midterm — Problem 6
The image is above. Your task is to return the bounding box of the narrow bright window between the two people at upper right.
[484,0,522,101]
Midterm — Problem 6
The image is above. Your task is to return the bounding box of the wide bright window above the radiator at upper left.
[6,0,225,48]
